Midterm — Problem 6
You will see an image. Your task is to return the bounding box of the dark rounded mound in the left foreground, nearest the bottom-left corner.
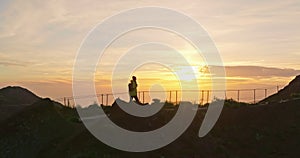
[0,99,84,158]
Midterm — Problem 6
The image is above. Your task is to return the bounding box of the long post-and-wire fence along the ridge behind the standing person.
[56,86,280,108]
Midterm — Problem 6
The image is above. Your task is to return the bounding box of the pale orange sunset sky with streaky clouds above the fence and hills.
[0,0,300,101]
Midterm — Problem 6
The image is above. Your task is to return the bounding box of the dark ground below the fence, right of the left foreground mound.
[40,100,300,158]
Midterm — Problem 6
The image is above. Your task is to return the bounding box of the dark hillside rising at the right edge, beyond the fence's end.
[261,75,300,103]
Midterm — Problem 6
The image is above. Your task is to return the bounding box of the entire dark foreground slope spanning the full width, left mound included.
[0,100,300,158]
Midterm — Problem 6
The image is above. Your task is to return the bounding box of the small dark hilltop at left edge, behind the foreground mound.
[0,86,41,105]
